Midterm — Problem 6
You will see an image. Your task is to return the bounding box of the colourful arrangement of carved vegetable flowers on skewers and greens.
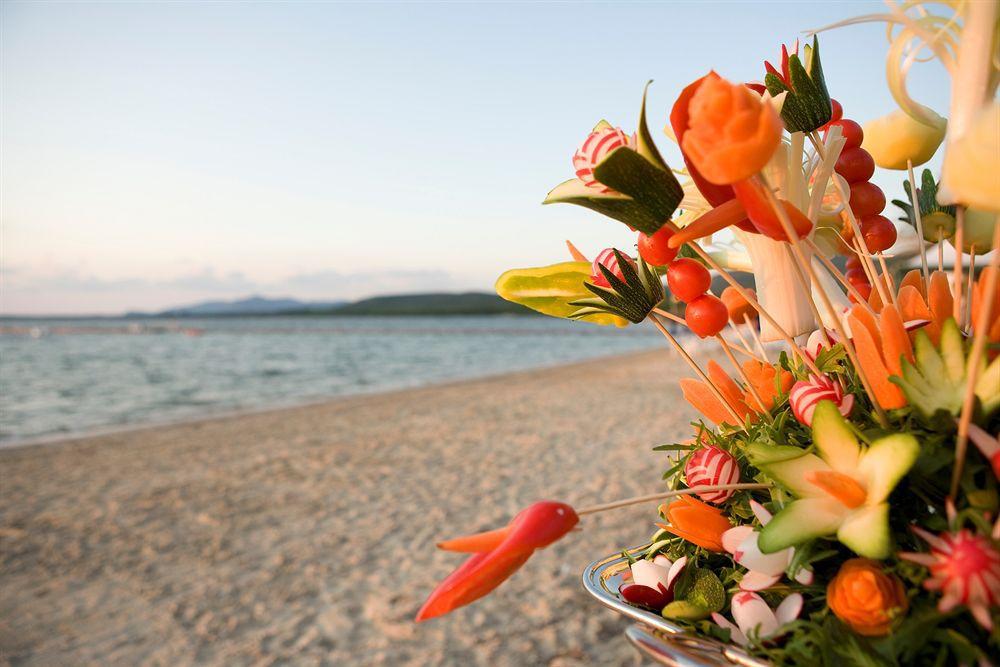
[417,0,1000,665]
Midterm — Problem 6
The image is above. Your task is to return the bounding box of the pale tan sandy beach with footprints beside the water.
[0,351,693,665]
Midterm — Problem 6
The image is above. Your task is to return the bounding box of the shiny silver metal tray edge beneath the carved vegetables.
[583,544,769,667]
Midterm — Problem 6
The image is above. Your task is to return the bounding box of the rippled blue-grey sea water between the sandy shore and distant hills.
[0,316,664,446]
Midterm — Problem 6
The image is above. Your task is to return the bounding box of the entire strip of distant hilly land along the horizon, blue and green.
[125,292,534,317]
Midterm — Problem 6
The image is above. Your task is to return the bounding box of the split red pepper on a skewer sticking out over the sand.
[416,500,580,622]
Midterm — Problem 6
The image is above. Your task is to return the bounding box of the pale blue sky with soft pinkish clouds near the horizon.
[0,0,948,314]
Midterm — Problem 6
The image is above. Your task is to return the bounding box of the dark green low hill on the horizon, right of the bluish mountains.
[324,292,533,316]
